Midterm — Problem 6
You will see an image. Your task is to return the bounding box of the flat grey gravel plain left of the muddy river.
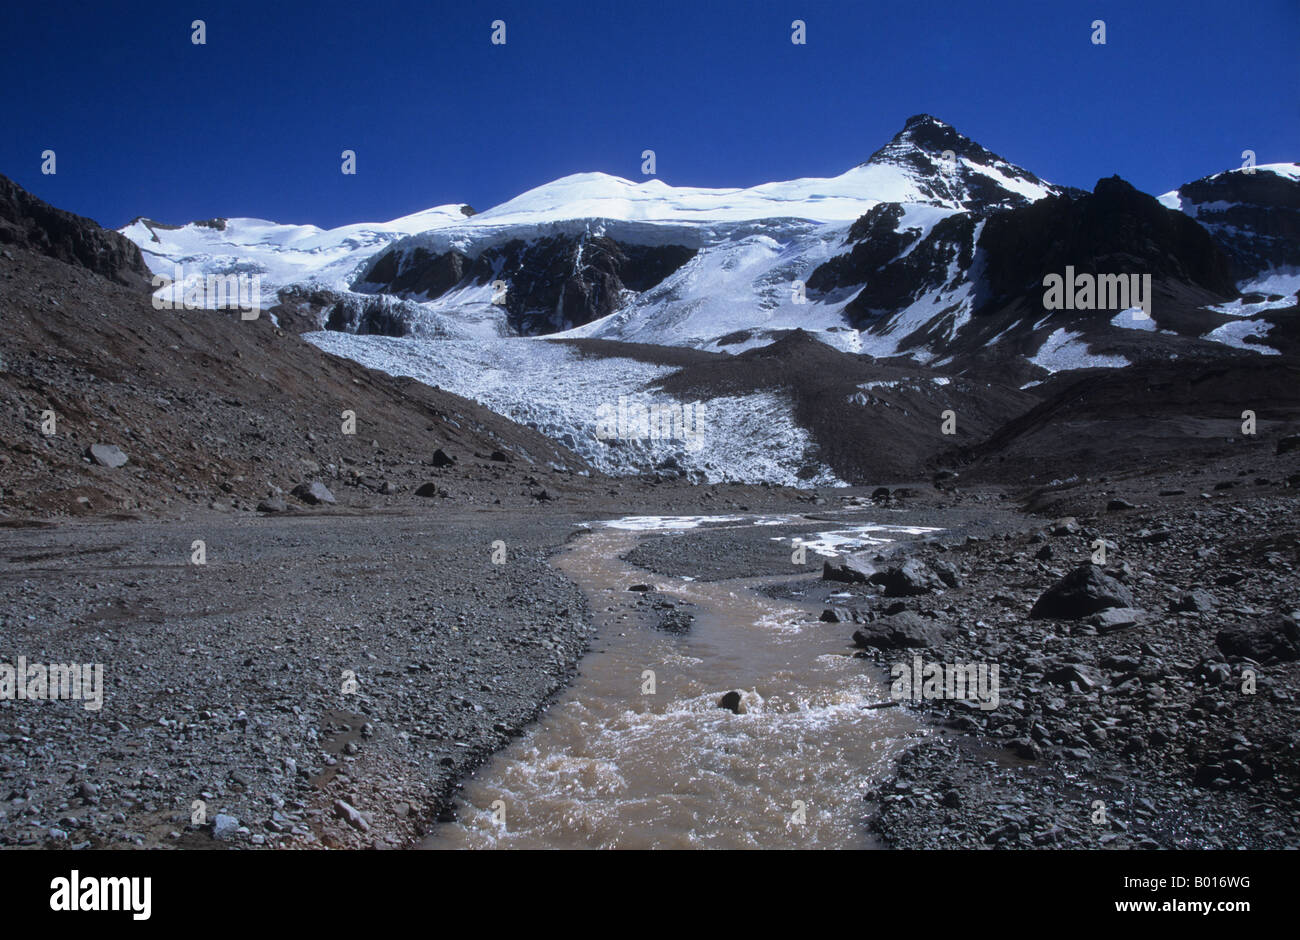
[0,488,816,848]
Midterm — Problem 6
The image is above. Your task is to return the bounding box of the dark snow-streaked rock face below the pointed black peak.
[807,172,1238,366]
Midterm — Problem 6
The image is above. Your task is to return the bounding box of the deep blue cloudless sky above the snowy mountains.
[0,0,1300,226]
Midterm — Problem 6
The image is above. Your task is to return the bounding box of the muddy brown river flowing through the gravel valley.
[424,519,919,849]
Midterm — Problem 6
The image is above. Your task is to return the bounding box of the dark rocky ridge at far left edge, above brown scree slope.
[0,176,150,290]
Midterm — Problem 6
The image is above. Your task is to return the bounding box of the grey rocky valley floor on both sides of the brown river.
[0,456,1300,848]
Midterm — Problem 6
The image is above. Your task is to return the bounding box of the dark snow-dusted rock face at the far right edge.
[1178,169,1300,280]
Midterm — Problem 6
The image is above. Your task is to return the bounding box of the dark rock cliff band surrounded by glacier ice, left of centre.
[358,234,696,335]
